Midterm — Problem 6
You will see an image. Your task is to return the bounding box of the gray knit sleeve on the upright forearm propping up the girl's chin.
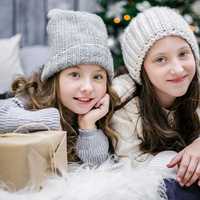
[76,129,109,165]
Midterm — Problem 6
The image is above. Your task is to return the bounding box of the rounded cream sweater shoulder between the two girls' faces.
[112,74,136,103]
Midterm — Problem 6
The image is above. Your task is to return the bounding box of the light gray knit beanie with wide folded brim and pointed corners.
[41,9,114,81]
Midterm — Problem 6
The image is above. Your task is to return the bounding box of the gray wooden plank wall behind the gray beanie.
[0,0,99,46]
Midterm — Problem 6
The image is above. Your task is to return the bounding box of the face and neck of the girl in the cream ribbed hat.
[144,36,196,107]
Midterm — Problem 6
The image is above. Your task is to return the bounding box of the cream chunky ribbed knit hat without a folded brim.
[121,7,199,84]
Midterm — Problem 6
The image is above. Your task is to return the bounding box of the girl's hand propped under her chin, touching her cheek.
[78,94,110,129]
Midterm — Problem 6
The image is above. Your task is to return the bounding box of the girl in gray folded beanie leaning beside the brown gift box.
[0,9,117,164]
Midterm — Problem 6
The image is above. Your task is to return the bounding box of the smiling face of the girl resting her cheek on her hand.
[59,64,107,114]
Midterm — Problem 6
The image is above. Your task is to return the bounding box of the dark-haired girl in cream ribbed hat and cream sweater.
[112,7,200,191]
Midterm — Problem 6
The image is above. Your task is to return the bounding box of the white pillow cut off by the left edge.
[0,34,24,94]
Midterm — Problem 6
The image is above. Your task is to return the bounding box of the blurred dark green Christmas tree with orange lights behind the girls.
[97,0,200,68]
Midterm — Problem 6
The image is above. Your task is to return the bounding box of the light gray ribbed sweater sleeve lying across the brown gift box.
[0,98,61,133]
